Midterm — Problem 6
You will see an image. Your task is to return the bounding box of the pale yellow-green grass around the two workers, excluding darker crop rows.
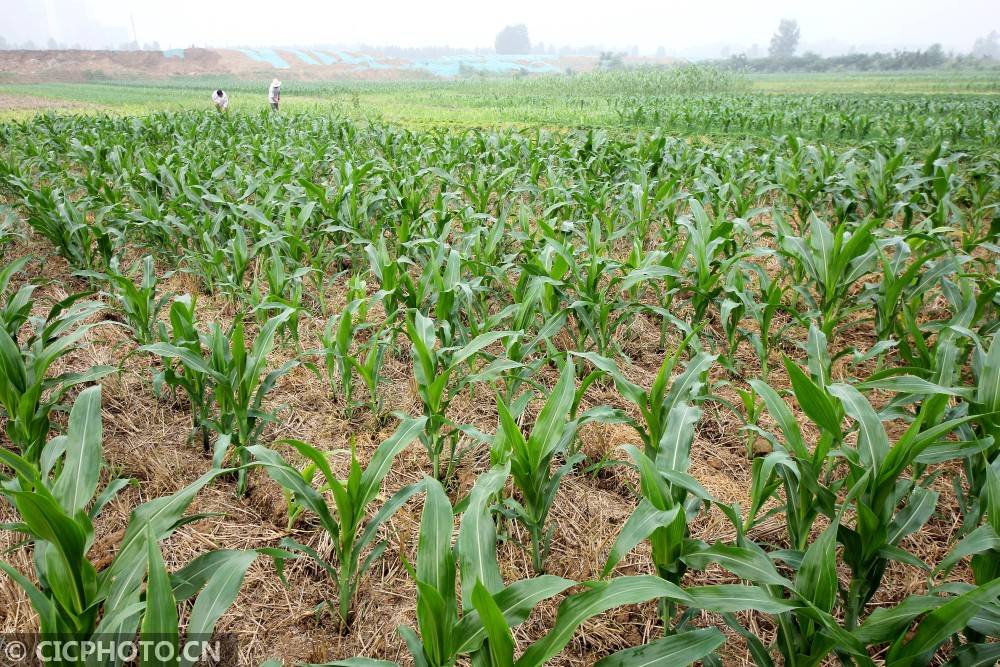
[0,71,1000,136]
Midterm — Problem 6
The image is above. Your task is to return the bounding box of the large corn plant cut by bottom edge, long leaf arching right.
[328,466,780,667]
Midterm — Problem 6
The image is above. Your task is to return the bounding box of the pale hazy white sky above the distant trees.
[0,0,1000,54]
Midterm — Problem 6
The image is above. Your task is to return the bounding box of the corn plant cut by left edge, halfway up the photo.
[0,288,117,465]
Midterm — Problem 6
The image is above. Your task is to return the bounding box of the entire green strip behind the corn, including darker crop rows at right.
[0,71,1000,139]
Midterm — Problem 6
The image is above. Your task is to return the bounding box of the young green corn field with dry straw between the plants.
[0,102,1000,667]
